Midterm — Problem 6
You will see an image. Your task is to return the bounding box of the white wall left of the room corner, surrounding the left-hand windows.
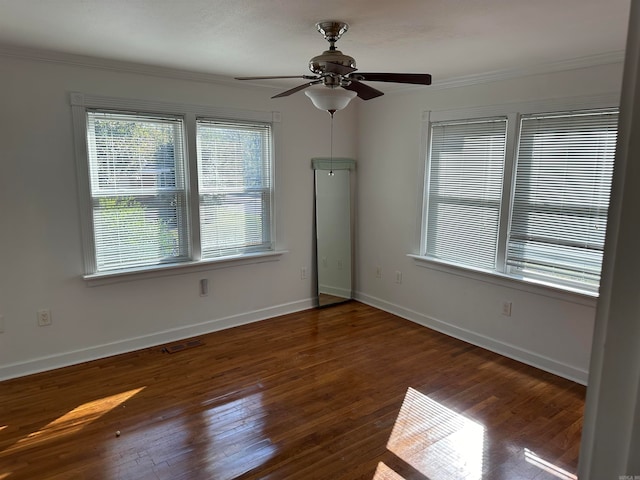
[0,56,356,379]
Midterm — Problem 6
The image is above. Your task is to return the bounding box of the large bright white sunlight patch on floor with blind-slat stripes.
[380,388,485,480]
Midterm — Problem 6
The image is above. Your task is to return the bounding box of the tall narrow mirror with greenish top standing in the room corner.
[312,158,355,307]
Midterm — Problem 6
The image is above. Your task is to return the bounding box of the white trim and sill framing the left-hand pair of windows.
[69,92,286,285]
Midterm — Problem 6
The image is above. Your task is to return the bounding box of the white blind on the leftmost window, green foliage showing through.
[87,111,189,272]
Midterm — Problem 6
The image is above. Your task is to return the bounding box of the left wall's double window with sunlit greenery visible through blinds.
[71,94,277,279]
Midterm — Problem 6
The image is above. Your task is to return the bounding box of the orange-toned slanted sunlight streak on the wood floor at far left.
[4,387,146,453]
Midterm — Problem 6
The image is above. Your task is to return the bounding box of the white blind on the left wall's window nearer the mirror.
[197,119,273,259]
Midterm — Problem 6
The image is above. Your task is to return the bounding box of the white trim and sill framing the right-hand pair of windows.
[416,93,620,298]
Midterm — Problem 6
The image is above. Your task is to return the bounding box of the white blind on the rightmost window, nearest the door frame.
[507,110,618,289]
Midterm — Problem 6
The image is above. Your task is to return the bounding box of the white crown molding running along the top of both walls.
[0,45,624,94]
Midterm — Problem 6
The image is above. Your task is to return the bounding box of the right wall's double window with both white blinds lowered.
[421,109,618,292]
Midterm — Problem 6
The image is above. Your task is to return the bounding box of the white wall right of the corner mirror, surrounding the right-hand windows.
[356,64,622,383]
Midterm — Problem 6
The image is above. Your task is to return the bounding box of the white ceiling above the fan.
[0,0,630,89]
